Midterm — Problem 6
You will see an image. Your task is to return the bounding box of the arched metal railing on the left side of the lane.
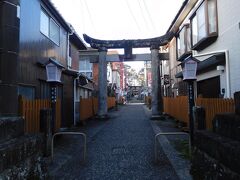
[51,132,87,162]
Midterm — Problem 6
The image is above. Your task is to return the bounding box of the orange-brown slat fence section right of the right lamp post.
[196,98,235,129]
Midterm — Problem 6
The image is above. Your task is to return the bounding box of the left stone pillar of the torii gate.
[98,47,107,119]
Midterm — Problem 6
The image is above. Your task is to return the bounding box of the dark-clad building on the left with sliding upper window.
[0,0,86,127]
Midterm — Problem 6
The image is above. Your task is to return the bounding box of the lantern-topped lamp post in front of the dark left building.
[45,58,64,132]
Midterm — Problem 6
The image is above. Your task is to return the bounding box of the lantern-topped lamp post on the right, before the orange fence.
[181,56,197,145]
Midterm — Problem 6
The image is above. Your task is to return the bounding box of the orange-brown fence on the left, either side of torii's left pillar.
[79,97,116,121]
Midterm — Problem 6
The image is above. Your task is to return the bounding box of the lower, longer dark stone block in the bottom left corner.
[0,135,43,173]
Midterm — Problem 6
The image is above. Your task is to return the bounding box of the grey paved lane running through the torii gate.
[49,104,178,180]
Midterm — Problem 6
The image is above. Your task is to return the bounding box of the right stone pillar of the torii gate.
[150,45,163,119]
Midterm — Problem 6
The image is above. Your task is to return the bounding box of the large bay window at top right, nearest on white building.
[190,0,218,50]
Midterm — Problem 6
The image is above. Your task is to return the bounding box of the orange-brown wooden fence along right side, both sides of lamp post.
[163,96,234,129]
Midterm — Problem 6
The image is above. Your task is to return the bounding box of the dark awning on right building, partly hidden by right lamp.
[175,53,225,78]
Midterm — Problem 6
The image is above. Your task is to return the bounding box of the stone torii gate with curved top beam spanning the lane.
[83,32,174,118]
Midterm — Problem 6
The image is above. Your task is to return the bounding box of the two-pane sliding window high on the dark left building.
[40,10,60,45]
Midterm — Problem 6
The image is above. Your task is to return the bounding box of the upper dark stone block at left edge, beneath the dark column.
[0,117,24,143]
